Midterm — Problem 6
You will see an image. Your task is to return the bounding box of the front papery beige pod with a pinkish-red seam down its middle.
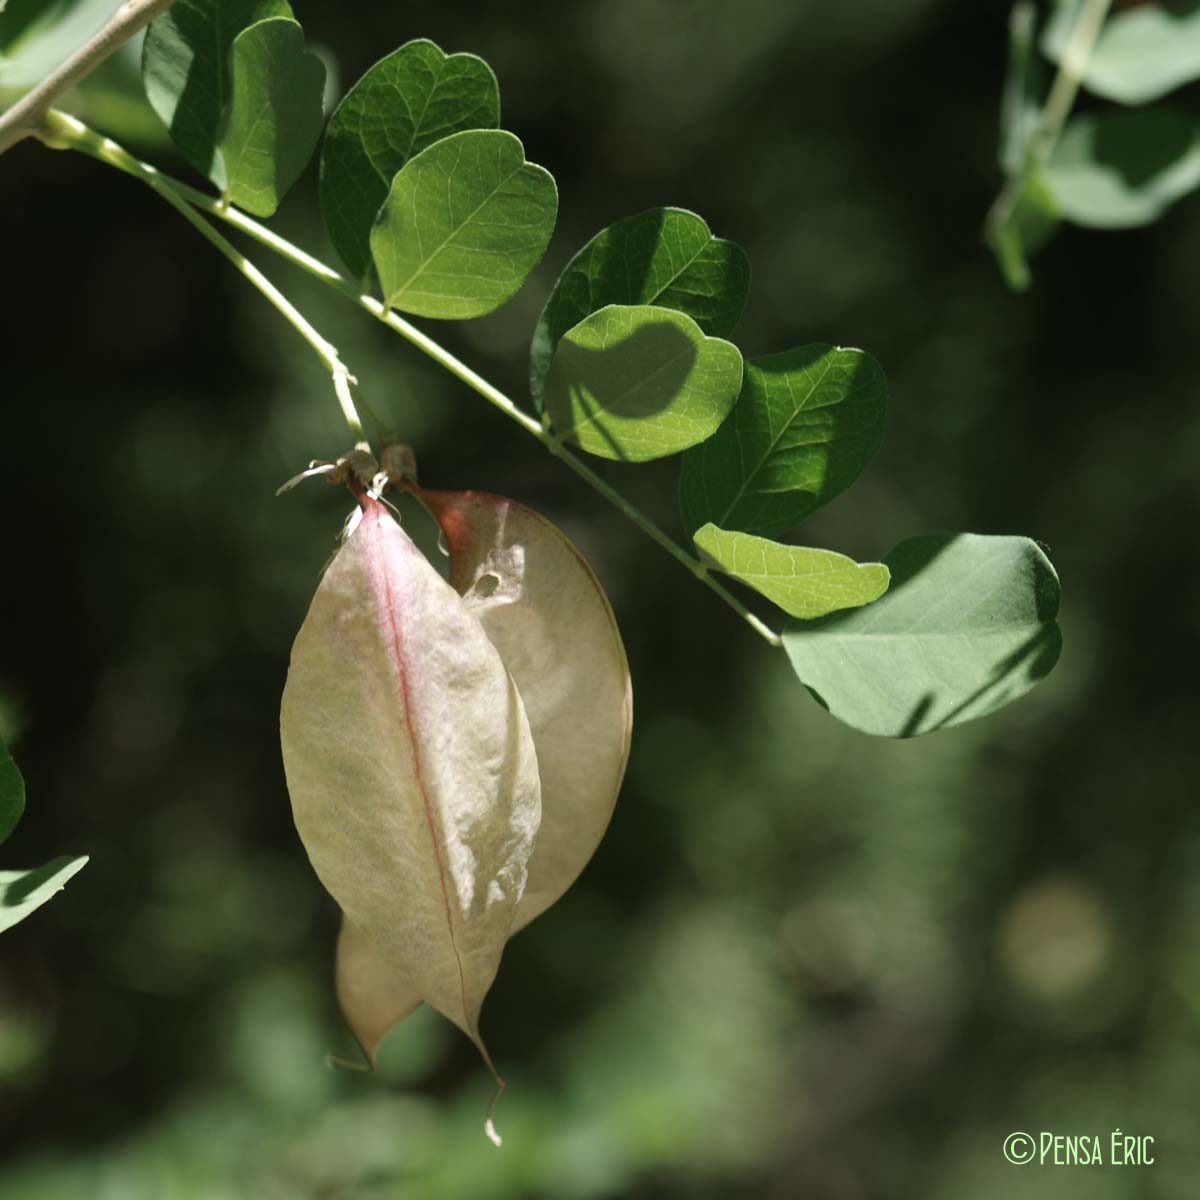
[280,497,541,1123]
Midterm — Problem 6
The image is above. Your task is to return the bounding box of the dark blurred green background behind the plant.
[0,0,1200,1200]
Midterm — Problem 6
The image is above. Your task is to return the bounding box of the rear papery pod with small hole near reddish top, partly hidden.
[337,487,632,1064]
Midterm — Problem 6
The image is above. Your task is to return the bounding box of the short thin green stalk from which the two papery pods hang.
[38,110,366,445]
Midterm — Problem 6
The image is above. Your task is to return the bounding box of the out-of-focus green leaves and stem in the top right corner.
[984,0,1200,290]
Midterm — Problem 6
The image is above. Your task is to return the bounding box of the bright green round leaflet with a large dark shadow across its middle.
[545,305,742,462]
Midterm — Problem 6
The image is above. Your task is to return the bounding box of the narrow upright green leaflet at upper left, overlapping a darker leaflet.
[220,18,325,216]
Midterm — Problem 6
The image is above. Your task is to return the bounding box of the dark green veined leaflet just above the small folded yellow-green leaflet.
[679,344,887,536]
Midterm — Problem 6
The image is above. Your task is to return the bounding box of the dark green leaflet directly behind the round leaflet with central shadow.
[529,209,750,407]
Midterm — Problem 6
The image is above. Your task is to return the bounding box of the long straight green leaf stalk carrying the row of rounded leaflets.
[42,113,782,646]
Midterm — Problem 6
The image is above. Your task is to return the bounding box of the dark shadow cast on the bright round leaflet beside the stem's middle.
[551,320,698,462]
